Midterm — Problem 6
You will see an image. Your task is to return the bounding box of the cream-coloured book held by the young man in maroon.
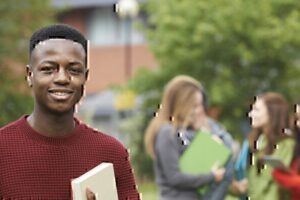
[71,163,118,200]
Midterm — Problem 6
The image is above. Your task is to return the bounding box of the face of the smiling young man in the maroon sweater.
[27,39,87,113]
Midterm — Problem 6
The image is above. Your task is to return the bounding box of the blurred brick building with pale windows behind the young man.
[52,0,158,95]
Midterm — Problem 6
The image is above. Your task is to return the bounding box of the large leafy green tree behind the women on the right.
[129,0,300,179]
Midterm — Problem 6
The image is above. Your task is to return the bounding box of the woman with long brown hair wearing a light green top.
[236,92,294,200]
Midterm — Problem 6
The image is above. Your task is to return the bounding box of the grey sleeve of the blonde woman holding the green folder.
[155,125,213,189]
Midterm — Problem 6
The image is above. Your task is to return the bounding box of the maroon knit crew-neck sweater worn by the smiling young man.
[0,116,139,200]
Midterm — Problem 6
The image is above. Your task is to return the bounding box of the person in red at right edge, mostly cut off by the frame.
[272,103,300,200]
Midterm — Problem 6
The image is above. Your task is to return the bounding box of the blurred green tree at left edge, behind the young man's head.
[0,0,55,127]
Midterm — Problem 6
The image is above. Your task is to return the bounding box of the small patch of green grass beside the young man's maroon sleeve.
[138,182,158,200]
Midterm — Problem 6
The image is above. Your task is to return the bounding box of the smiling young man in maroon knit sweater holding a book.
[0,24,139,200]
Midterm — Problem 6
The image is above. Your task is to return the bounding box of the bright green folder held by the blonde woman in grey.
[179,131,231,194]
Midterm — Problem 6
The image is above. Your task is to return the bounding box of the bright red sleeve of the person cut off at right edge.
[272,161,300,200]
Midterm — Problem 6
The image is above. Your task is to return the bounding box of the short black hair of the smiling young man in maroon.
[29,24,87,57]
